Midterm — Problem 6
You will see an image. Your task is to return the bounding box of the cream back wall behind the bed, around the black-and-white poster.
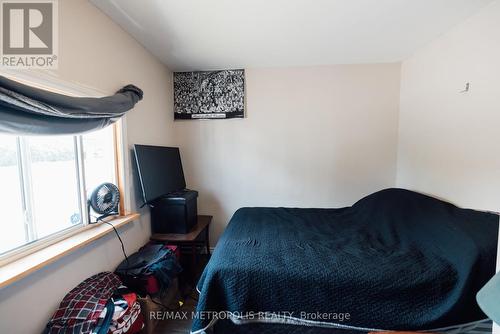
[174,64,400,241]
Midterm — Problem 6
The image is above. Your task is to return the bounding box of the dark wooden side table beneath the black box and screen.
[150,215,213,270]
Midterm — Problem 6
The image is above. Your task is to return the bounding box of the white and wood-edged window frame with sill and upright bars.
[0,71,130,268]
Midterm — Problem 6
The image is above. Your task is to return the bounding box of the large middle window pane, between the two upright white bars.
[26,136,82,239]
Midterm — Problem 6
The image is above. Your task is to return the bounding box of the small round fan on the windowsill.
[88,183,120,222]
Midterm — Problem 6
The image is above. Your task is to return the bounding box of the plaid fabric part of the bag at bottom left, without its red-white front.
[46,272,121,334]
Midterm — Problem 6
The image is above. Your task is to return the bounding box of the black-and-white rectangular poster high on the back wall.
[174,70,245,119]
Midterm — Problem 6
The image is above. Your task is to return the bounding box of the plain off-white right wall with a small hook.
[397,1,500,211]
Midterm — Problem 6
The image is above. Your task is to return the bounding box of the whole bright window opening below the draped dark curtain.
[0,126,116,257]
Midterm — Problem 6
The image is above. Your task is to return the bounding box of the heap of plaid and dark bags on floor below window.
[43,244,181,334]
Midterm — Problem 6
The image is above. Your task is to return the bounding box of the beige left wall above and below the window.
[0,0,173,334]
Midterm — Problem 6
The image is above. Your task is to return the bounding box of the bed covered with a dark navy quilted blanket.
[192,189,498,334]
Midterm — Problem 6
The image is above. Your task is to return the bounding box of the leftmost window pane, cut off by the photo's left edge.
[0,135,27,253]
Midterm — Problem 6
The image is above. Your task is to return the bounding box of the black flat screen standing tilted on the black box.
[134,145,186,203]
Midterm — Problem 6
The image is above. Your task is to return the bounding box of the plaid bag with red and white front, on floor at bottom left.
[44,272,144,334]
